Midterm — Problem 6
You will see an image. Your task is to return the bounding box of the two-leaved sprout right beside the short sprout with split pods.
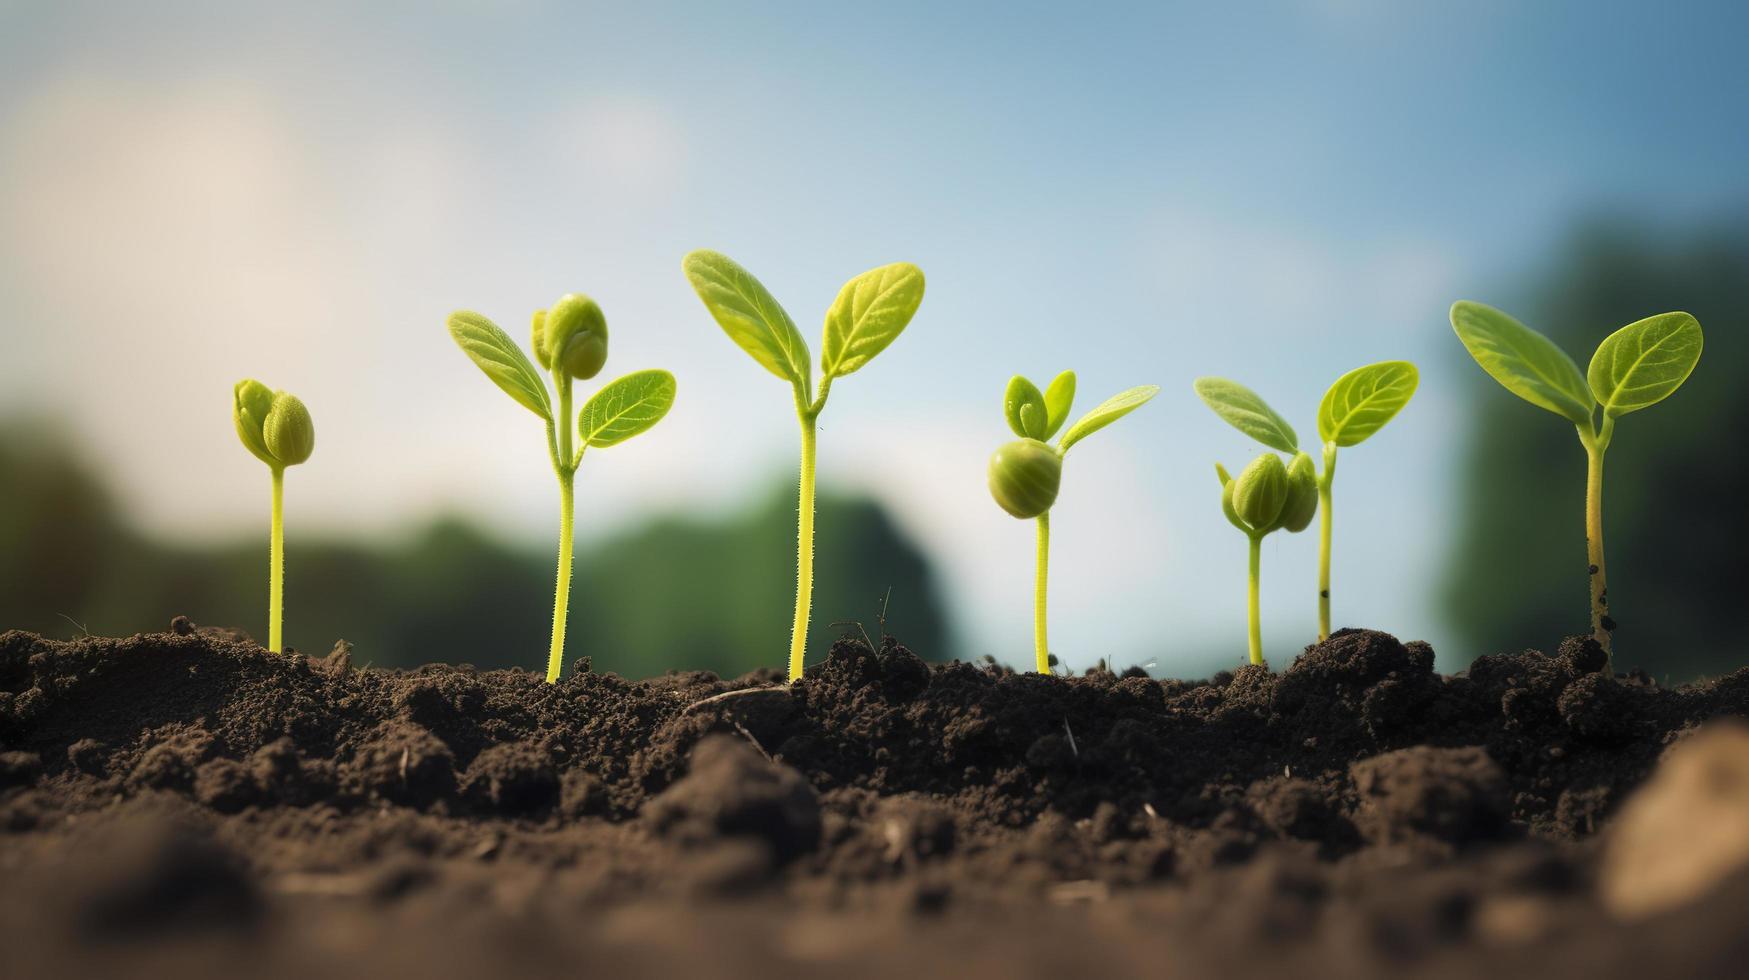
[1196,361,1420,642]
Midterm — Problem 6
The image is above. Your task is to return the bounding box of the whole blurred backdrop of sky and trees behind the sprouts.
[0,0,1749,681]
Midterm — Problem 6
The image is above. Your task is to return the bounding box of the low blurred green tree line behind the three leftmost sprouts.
[0,420,948,677]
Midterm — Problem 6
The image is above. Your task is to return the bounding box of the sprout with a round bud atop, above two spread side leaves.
[449,292,675,684]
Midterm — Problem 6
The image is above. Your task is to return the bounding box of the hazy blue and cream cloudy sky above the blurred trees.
[0,0,1749,674]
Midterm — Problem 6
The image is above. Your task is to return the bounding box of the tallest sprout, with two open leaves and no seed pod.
[682,249,923,681]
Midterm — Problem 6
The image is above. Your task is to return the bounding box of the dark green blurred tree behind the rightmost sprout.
[1445,219,1749,681]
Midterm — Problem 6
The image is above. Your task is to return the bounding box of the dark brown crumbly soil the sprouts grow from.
[0,620,1749,980]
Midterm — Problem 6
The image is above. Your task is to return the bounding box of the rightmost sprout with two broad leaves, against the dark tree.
[1452,301,1702,655]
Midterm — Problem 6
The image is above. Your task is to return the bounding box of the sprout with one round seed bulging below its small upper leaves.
[990,371,1160,674]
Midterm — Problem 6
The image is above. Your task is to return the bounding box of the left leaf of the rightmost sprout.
[1452,299,1592,425]
